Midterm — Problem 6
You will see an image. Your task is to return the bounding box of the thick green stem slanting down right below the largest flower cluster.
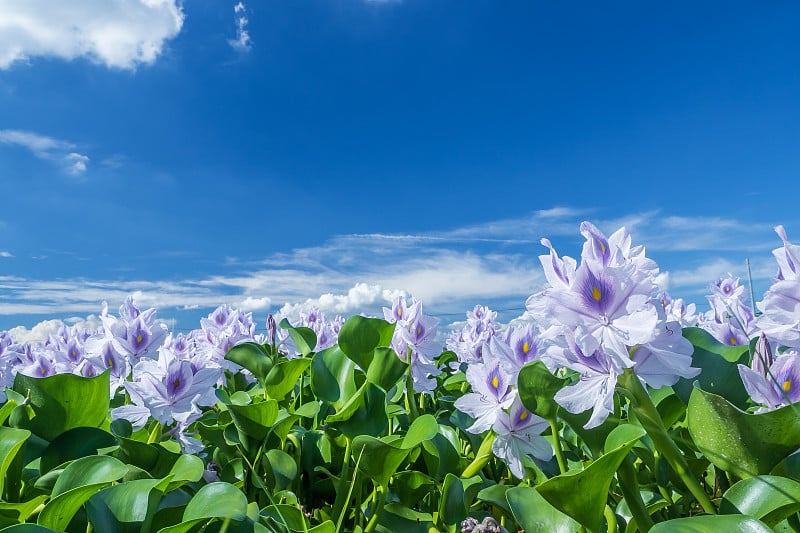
[617,368,717,514]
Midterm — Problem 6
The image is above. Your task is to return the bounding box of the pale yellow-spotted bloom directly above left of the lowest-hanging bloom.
[455,361,517,433]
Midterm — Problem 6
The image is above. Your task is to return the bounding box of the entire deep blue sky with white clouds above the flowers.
[0,0,800,336]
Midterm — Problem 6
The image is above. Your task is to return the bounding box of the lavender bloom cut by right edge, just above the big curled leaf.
[738,350,800,413]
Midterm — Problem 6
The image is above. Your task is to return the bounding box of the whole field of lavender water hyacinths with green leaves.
[0,222,800,533]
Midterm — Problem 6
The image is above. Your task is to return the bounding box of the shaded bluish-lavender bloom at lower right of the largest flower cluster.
[631,322,701,389]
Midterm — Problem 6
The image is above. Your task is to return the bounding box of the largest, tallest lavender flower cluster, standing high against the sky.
[527,222,700,429]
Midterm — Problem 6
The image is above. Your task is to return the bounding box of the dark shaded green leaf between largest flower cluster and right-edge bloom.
[672,328,749,409]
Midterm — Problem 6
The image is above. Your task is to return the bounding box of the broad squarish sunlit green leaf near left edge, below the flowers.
[14,370,110,441]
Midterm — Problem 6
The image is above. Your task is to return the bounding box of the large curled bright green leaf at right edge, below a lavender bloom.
[686,388,800,478]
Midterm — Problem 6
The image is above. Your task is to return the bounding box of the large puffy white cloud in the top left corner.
[0,0,184,69]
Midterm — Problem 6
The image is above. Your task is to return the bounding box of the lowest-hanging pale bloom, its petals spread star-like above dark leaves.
[492,398,553,479]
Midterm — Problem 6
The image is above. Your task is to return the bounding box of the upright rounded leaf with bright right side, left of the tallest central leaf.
[311,345,357,410]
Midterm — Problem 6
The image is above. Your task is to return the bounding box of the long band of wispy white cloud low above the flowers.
[0,208,792,327]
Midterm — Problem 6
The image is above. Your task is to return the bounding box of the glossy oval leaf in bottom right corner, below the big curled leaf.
[719,476,800,527]
